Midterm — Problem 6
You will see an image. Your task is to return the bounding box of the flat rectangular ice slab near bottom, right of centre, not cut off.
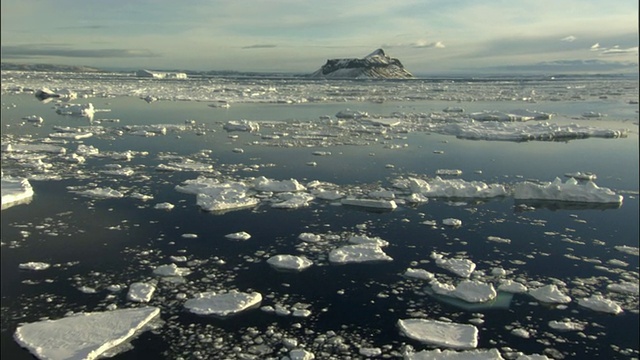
[398,319,478,349]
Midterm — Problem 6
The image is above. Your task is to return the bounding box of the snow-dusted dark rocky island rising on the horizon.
[310,49,413,79]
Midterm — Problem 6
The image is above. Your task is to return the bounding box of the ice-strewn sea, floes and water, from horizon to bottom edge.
[1,71,640,360]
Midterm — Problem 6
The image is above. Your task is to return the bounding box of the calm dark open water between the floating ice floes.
[1,74,639,359]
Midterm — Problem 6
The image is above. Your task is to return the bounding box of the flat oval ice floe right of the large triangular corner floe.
[184,291,262,317]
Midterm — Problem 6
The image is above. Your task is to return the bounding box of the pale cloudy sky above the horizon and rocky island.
[1,0,638,74]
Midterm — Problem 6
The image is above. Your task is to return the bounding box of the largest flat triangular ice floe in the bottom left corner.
[14,307,160,359]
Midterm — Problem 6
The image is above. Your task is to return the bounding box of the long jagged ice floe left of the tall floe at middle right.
[394,176,510,198]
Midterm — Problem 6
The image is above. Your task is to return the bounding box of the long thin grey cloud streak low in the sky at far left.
[2,45,160,59]
